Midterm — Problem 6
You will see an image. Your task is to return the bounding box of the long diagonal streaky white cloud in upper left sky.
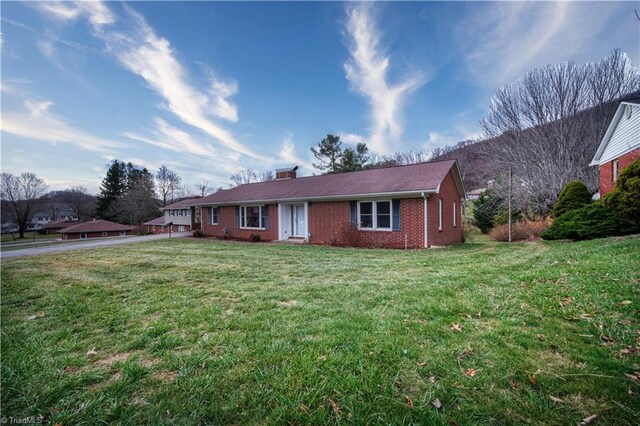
[30,1,261,159]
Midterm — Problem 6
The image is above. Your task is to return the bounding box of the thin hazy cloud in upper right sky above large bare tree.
[453,2,640,87]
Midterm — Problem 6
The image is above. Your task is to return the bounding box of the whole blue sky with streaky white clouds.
[0,2,640,193]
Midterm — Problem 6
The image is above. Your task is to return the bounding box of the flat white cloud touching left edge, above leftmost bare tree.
[2,99,123,153]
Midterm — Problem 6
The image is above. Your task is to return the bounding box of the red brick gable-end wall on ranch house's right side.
[427,172,462,246]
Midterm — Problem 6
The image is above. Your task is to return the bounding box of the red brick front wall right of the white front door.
[309,198,424,248]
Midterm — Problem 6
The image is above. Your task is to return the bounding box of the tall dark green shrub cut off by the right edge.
[604,158,640,228]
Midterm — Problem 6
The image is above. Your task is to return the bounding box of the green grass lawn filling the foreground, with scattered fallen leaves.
[1,238,640,425]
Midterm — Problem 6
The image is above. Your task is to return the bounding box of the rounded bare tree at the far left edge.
[0,172,47,238]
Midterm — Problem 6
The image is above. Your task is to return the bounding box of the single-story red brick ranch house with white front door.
[190,160,464,248]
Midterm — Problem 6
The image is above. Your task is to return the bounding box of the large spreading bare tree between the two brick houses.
[480,50,640,216]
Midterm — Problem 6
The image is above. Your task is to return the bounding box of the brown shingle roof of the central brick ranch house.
[189,160,463,205]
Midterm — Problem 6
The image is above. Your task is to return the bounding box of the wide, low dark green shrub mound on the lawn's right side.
[541,202,634,240]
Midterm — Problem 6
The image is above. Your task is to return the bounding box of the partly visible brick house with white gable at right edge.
[591,98,640,197]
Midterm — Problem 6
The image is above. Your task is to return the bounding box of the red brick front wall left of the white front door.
[202,204,278,241]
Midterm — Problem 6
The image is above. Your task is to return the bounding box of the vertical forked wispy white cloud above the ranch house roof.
[344,3,426,154]
